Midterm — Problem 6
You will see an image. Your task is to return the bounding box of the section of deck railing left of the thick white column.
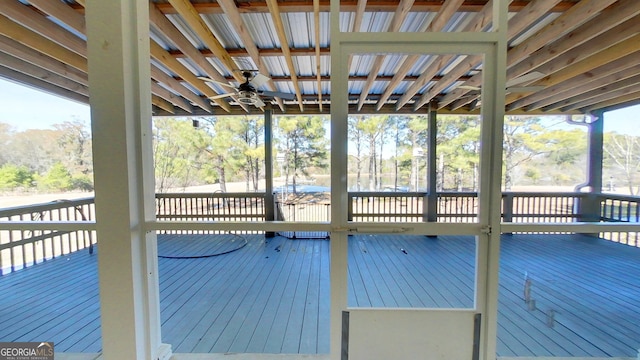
[0,197,96,274]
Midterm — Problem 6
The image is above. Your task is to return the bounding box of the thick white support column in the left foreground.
[86,0,171,360]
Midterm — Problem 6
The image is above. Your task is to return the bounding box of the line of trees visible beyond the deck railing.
[0,115,640,194]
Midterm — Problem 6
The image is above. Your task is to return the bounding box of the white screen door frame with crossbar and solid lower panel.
[330,0,507,360]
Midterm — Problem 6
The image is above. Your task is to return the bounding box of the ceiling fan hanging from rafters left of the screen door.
[198,70,296,108]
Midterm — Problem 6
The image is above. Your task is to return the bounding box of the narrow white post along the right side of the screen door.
[476,1,509,360]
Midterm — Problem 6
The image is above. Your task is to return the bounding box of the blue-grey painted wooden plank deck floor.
[0,235,640,357]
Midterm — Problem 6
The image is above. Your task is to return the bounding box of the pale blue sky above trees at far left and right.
[0,78,640,135]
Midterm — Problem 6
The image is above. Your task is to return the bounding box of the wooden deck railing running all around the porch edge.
[0,192,640,274]
